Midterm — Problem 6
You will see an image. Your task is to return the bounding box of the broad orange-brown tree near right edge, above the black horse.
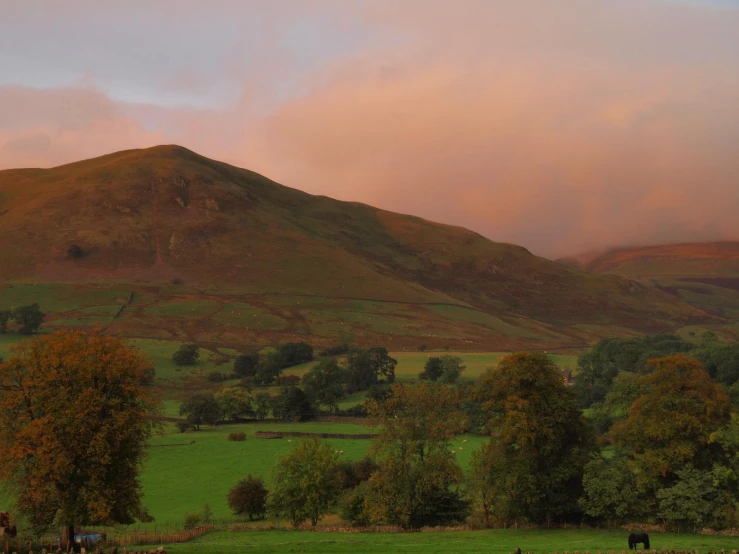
[613,355,734,501]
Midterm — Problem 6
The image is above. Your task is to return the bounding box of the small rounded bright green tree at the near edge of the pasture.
[267,439,341,527]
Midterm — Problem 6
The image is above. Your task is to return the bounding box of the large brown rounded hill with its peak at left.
[0,146,711,346]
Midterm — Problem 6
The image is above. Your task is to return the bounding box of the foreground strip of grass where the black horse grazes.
[139,529,738,554]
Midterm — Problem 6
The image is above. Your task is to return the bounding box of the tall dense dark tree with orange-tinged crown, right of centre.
[478,352,594,523]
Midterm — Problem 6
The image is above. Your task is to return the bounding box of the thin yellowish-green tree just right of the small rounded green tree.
[364,382,466,528]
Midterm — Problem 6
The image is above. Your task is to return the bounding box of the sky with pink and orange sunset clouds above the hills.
[0,0,739,257]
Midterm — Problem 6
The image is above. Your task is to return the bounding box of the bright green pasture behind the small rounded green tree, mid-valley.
[142,422,484,525]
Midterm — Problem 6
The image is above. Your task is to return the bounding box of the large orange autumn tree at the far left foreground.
[0,331,157,543]
